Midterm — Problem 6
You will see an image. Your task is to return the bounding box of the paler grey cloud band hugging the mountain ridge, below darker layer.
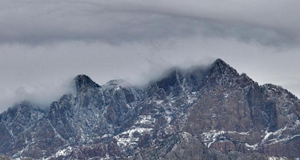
[0,37,299,111]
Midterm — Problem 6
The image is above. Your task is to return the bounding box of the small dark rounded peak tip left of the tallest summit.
[74,74,100,91]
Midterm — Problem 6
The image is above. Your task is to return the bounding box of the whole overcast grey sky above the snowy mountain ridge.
[0,0,300,112]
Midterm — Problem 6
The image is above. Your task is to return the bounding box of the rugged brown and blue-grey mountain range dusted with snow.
[0,59,300,160]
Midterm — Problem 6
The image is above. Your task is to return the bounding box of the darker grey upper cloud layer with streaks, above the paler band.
[0,0,300,47]
